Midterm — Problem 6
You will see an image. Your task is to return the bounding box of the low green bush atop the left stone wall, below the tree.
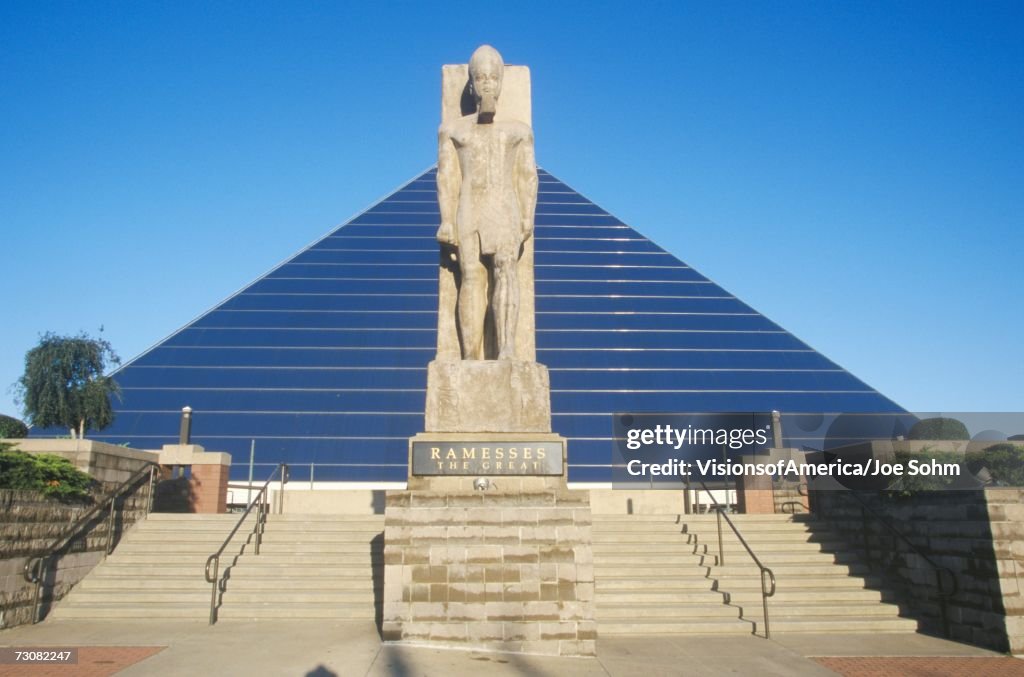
[0,446,98,501]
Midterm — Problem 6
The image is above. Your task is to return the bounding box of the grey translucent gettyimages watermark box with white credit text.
[611,412,1024,491]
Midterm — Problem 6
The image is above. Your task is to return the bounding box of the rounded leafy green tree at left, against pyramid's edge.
[16,332,121,437]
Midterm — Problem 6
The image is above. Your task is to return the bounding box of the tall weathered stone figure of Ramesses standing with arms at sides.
[437,45,538,359]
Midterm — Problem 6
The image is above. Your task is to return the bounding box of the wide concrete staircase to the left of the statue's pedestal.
[51,513,384,621]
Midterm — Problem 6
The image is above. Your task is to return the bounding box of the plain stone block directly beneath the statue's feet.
[426,359,551,432]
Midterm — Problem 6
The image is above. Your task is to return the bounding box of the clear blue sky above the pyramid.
[0,1,1024,415]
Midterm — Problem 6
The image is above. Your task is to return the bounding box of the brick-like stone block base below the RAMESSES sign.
[383,478,597,655]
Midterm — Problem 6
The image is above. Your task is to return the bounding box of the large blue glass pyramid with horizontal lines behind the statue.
[90,169,902,482]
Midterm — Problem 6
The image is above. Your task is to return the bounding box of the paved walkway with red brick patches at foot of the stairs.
[0,621,1011,677]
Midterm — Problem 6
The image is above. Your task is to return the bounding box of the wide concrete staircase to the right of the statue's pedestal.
[594,514,918,636]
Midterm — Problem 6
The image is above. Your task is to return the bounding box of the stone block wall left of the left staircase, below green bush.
[0,481,147,628]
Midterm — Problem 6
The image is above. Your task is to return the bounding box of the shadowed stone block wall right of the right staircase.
[812,489,1024,653]
